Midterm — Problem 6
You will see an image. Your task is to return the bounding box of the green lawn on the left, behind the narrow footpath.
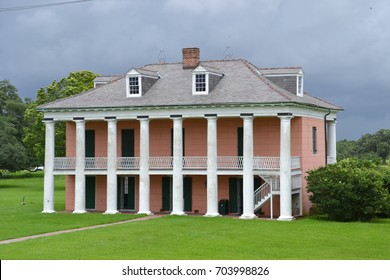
[0,173,145,240]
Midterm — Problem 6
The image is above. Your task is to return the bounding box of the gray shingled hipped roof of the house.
[38,60,341,110]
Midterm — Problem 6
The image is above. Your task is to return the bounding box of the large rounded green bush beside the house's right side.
[306,158,390,221]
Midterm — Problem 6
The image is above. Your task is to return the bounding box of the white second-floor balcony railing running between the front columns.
[54,156,301,170]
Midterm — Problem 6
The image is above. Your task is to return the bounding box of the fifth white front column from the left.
[171,115,185,215]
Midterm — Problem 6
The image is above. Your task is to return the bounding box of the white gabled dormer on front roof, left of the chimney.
[126,68,161,97]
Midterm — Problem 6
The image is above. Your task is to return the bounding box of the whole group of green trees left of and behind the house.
[0,71,97,171]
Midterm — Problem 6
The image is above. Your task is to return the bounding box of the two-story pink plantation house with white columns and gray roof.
[38,48,342,220]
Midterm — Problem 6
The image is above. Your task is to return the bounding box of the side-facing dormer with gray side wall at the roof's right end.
[259,67,304,97]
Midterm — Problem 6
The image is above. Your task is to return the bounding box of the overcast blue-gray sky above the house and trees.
[0,0,390,140]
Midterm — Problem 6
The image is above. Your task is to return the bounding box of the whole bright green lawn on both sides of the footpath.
[0,174,390,260]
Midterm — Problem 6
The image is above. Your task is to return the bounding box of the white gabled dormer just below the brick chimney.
[192,65,223,95]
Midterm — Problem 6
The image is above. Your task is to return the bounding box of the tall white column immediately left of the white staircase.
[240,114,256,219]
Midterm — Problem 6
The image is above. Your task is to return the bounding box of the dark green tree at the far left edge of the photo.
[0,80,29,171]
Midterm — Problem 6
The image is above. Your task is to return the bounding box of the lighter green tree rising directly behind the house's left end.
[23,71,97,164]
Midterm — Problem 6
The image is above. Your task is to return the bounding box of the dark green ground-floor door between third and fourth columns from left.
[117,176,135,210]
